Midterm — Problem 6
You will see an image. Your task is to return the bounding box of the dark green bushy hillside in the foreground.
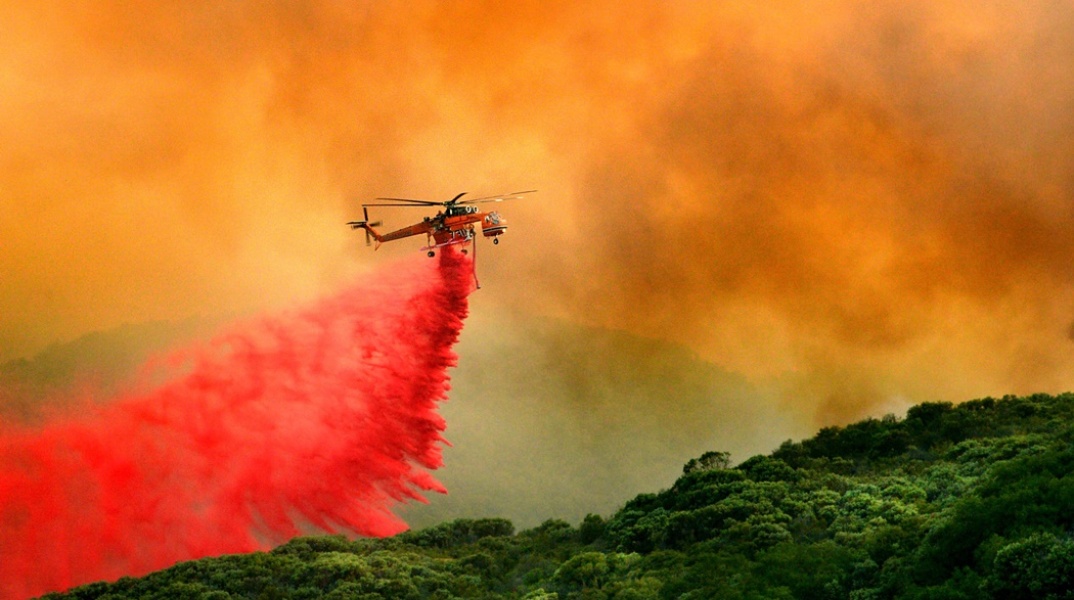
[39,394,1074,600]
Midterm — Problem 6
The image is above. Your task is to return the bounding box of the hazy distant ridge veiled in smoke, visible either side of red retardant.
[0,310,807,527]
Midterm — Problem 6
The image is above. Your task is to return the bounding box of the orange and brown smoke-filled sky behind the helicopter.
[6,0,1074,442]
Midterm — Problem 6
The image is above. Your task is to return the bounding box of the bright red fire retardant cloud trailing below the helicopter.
[0,251,473,598]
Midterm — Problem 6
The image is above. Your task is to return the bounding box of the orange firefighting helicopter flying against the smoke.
[347,190,537,258]
